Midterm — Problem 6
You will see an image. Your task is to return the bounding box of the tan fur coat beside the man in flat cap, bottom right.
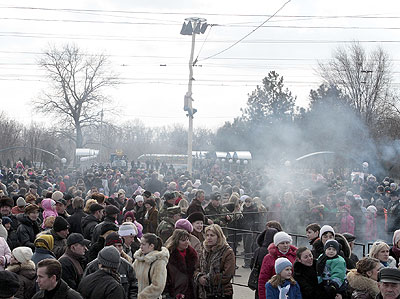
[347,269,379,299]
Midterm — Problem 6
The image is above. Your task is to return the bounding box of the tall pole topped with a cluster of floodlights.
[181,17,208,174]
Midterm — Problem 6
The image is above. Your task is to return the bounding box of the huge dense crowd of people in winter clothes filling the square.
[0,163,400,299]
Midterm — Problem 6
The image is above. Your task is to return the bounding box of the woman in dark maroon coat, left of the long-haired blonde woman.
[165,229,198,298]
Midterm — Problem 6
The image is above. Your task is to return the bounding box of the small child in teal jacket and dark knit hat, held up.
[317,240,347,298]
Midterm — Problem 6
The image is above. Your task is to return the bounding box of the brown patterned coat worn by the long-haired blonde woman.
[195,244,236,299]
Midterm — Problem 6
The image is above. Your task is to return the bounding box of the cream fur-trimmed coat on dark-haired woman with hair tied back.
[133,247,169,299]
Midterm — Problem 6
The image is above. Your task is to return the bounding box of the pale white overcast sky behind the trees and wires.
[0,0,400,129]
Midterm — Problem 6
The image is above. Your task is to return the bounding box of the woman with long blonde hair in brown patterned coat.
[194,224,236,299]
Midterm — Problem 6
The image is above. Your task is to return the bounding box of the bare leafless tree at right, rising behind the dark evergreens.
[319,43,393,128]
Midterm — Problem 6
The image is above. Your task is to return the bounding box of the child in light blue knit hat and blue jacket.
[265,257,301,299]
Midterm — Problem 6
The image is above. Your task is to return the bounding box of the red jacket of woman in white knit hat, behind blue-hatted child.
[258,243,297,298]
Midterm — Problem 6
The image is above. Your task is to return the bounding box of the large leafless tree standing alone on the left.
[34,45,118,148]
